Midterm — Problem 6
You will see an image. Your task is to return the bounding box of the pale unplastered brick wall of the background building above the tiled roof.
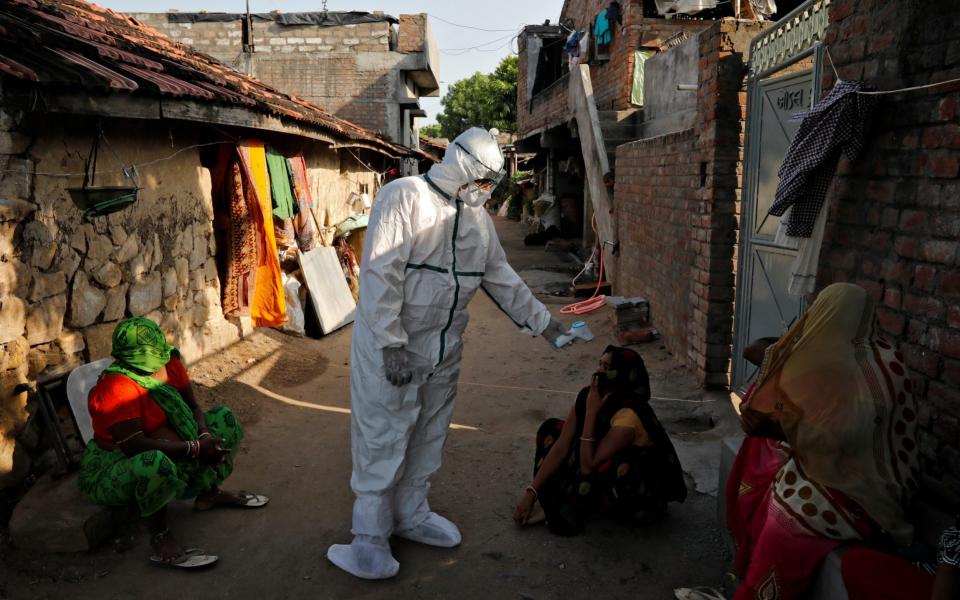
[132,13,427,143]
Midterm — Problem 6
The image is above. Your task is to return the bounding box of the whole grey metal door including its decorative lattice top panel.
[732,0,830,394]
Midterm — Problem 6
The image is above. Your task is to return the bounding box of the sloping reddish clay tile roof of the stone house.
[0,0,422,157]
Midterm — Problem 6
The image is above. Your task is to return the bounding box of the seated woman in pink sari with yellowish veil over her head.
[726,284,918,600]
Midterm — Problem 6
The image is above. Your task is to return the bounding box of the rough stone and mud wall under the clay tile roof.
[0,101,379,489]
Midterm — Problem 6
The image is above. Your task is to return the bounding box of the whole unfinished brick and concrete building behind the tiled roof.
[132,12,440,148]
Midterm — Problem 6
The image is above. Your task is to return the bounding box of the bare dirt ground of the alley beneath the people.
[0,219,735,600]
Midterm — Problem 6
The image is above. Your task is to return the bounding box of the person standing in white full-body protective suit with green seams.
[327,128,564,579]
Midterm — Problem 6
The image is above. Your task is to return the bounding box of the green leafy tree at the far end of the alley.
[437,56,517,140]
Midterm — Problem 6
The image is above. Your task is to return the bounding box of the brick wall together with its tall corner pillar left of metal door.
[614,19,765,387]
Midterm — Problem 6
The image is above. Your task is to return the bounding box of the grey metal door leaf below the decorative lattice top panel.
[733,70,813,393]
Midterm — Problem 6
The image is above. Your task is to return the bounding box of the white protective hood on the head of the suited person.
[427,127,505,204]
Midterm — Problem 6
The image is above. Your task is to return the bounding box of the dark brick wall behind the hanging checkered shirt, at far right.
[818,0,960,500]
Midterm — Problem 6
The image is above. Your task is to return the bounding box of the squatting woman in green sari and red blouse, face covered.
[80,317,267,567]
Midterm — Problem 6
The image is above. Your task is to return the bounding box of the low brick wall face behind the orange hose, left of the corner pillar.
[614,129,700,359]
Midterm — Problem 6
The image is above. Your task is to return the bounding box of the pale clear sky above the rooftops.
[94,0,563,124]
